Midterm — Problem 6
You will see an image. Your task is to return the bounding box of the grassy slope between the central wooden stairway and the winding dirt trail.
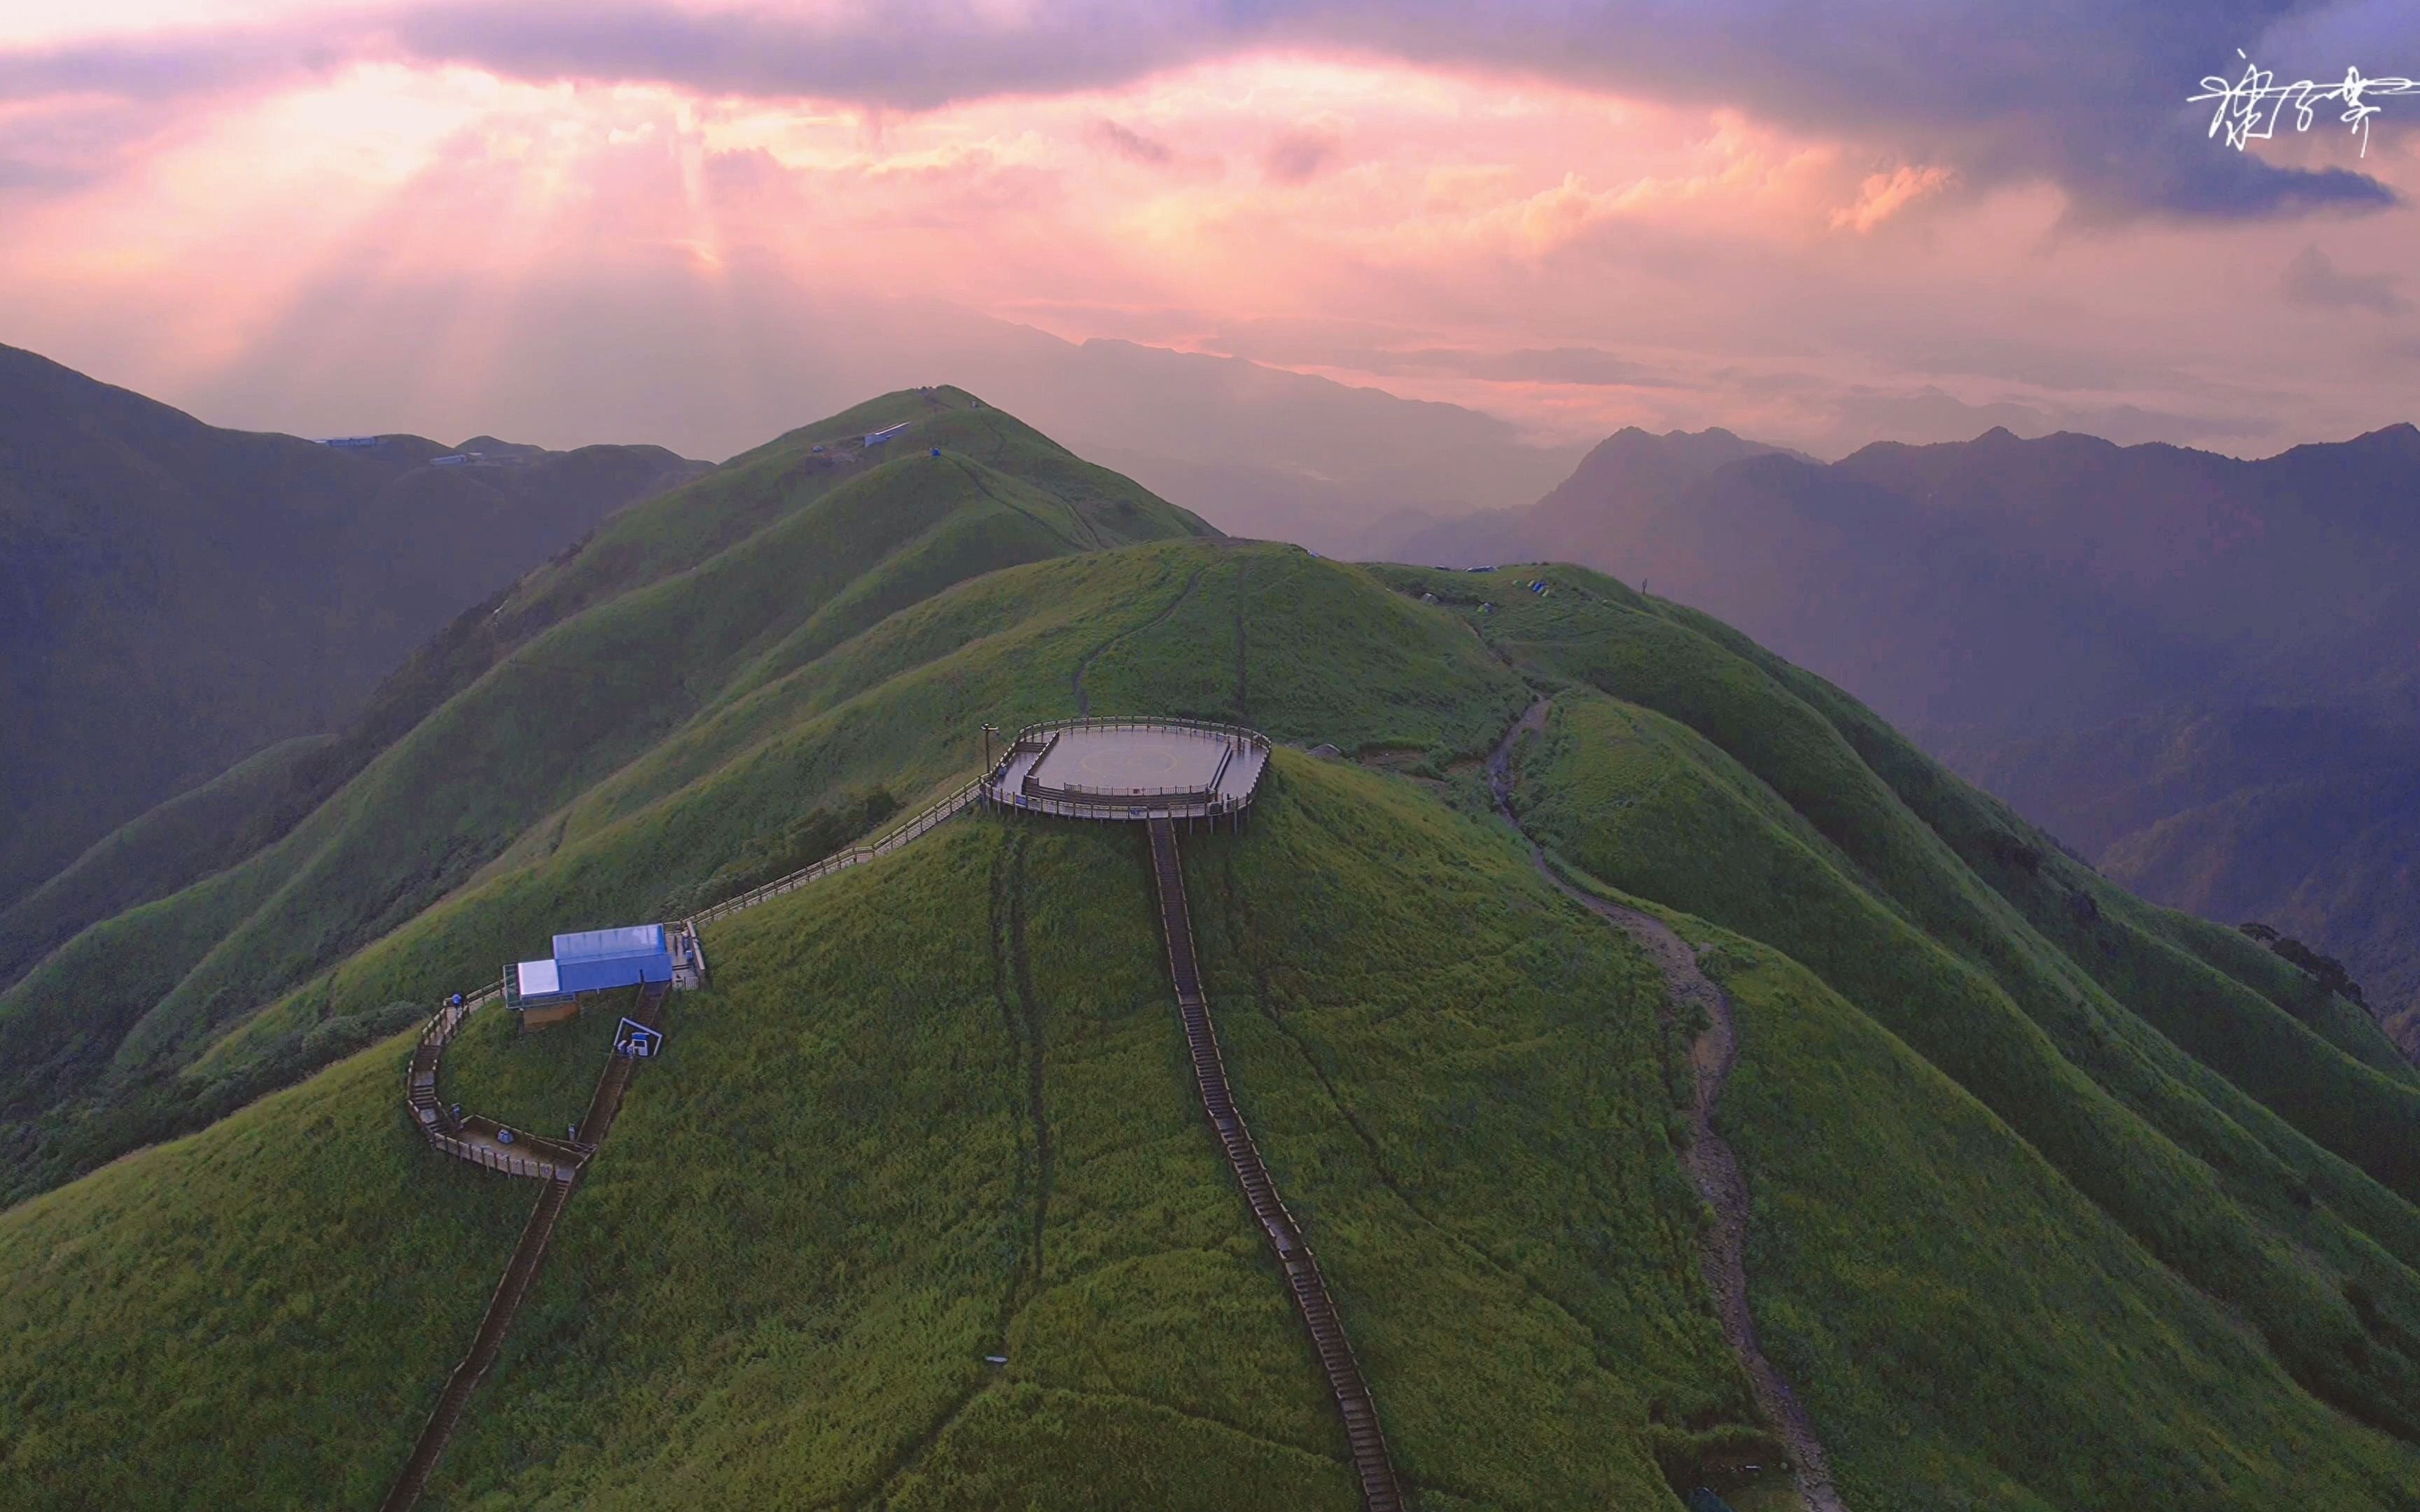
[1185,757,1755,1507]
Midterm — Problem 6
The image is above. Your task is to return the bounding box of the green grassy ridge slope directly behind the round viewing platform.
[196,542,1524,1098]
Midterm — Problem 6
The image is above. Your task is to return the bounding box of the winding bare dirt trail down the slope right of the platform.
[1488,699,1847,1512]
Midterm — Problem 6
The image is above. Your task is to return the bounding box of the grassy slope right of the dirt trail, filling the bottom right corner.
[1684,924,2415,1512]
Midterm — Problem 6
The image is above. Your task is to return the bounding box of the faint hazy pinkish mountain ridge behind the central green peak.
[176,283,1587,556]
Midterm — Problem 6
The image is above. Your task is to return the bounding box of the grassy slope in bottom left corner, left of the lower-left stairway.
[0,1043,535,1507]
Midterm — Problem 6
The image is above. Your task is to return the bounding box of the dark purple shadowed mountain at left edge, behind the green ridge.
[0,349,704,909]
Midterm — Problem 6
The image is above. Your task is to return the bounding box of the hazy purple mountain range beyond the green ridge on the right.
[1386,426,2420,1052]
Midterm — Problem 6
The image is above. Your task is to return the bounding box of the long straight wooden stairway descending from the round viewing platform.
[1150,818,1403,1512]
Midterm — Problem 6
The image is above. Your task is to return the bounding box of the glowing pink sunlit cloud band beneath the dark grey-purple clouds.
[0,24,2420,467]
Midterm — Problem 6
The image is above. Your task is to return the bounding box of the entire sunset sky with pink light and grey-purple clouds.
[0,0,2420,457]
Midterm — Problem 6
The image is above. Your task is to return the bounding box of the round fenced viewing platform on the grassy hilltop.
[982,718,1268,820]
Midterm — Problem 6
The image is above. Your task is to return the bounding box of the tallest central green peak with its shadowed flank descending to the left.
[0,392,1203,1193]
